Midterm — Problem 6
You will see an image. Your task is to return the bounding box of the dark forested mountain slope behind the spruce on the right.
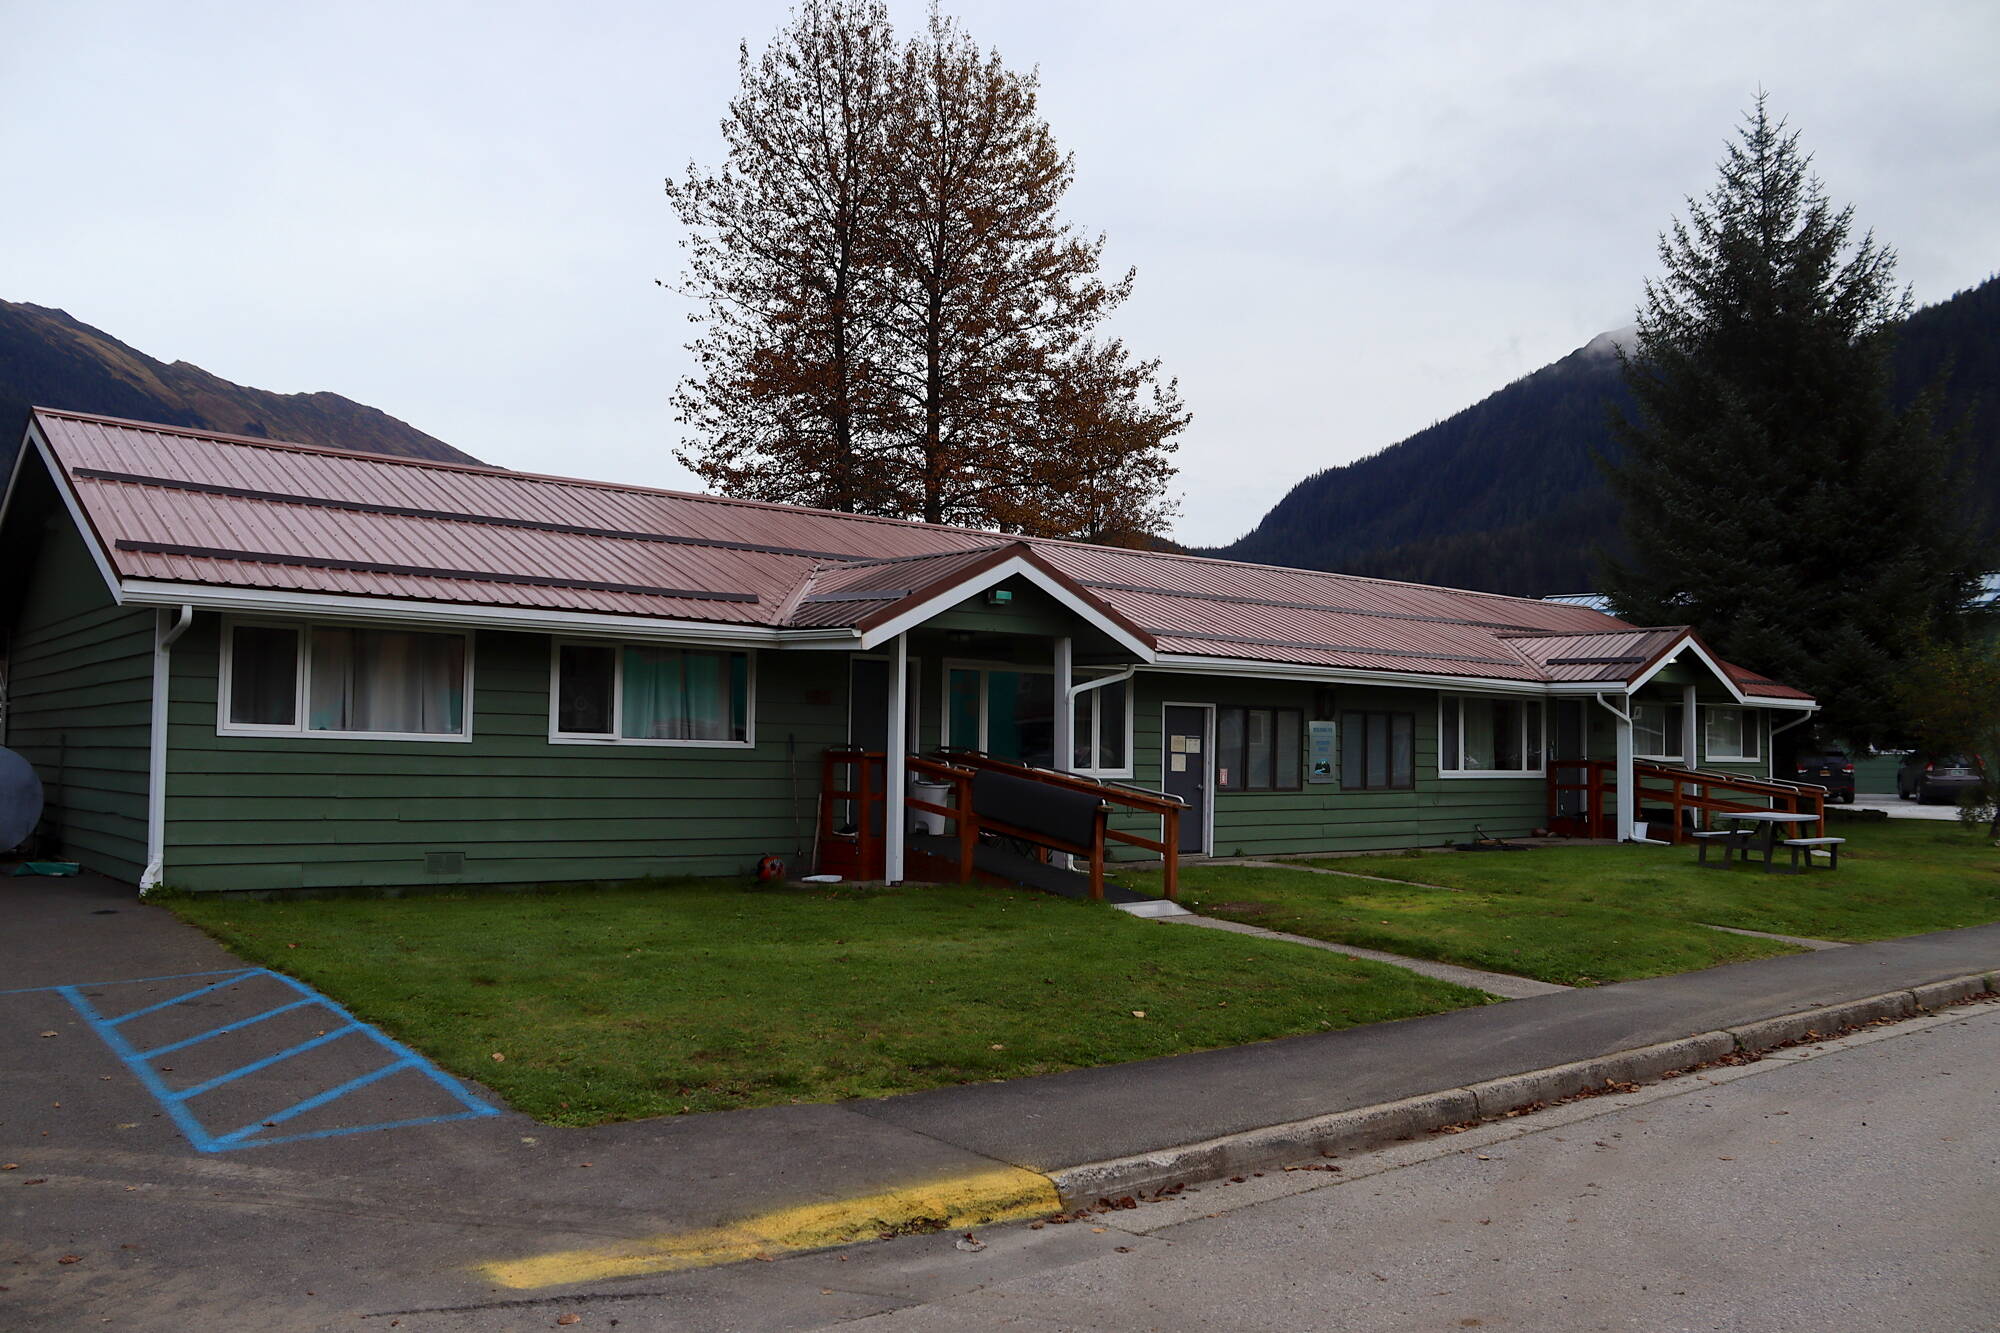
[1200,278,2000,596]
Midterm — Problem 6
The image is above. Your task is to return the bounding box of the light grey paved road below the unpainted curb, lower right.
[788,1005,2000,1333]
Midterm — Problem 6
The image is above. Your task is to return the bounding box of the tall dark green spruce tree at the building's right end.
[1606,96,1978,745]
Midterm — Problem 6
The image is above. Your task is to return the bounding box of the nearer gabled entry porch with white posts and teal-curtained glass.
[792,542,1182,899]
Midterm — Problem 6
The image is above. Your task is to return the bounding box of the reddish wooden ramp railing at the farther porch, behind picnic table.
[1548,759,1826,843]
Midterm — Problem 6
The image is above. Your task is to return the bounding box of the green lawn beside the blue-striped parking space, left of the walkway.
[170,875,1486,1125]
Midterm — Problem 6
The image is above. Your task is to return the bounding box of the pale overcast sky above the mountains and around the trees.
[0,0,2000,544]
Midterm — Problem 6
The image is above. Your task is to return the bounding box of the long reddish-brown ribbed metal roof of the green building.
[34,408,1804,699]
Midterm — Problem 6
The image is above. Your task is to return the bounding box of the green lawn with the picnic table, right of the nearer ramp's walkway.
[1130,821,2000,985]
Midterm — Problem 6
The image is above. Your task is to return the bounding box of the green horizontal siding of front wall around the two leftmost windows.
[166,614,846,891]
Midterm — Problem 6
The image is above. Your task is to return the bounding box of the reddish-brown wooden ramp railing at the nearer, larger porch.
[816,749,1188,901]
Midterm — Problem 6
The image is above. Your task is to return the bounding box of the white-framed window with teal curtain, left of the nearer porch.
[554,642,750,745]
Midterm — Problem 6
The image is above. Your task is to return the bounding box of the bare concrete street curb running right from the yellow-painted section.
[1046,973,2000,1209]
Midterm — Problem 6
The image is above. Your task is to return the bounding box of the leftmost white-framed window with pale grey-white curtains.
[220,622,470,741]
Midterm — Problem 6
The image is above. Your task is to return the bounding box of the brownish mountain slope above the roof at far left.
[0,300,478,466]
